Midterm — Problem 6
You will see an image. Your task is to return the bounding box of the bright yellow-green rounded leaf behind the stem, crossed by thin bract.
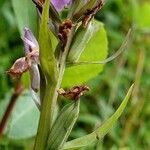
[62,22,108,87]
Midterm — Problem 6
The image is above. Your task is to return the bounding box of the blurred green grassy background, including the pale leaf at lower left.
[0,0,150,150]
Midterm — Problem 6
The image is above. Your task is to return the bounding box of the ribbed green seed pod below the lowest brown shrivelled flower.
[47,101,80,150]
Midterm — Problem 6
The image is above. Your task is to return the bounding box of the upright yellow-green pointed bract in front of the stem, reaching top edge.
[39,0,57,82]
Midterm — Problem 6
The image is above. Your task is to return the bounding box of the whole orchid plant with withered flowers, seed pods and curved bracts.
[7,0,133,150]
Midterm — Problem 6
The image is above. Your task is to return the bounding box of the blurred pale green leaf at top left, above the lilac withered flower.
[12,0,37,35]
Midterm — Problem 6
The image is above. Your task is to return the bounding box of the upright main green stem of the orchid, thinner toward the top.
[34,26,74,150]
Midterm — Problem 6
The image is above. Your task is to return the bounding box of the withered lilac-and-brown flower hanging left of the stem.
[7,28,40,92]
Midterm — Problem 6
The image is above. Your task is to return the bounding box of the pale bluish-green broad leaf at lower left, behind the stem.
[6,91,39,139]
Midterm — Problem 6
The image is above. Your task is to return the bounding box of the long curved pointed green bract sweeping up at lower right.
[63,85,133,150]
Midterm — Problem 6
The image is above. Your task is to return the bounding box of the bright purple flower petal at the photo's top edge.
[51,0,72,11]
